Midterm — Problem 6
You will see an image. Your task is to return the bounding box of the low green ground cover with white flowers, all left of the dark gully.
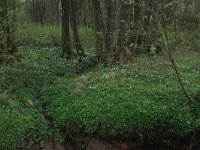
[0,48,73,149]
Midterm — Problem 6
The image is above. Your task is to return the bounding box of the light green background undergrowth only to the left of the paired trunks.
[16,24,61,46]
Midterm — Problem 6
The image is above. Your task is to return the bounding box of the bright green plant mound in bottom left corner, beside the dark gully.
[0,93,48,149]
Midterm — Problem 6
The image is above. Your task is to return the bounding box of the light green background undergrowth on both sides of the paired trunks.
[16,24,95,49]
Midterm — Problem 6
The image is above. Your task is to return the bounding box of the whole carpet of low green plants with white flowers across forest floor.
[0,47,200,149]
